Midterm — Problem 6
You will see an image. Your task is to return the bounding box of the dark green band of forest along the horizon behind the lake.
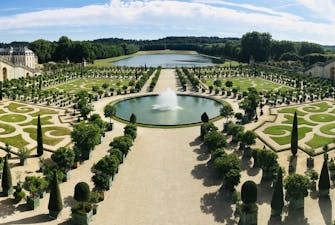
[0,32,334,66]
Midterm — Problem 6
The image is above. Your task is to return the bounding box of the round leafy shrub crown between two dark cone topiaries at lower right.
[284,174,309,201]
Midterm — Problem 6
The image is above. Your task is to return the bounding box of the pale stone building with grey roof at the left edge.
[0,47,38,69]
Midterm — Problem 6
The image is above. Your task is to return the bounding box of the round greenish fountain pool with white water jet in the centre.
[114,90,226,126]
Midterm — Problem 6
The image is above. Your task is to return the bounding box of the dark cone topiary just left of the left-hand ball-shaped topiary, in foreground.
[48,172,63,218]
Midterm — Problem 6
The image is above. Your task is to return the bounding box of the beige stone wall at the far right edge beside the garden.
[304,59,335,81]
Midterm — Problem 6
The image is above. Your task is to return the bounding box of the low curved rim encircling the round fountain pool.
[111,92,229,128]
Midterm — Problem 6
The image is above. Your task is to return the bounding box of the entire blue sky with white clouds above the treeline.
[0,0,335,45]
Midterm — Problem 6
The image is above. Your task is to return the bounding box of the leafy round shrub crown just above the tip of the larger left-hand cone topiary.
[51,147,75,172]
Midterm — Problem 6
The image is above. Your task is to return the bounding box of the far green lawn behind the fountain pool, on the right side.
[202,77,292,91]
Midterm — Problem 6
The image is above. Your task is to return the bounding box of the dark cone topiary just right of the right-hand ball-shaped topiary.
[271,167,284,216]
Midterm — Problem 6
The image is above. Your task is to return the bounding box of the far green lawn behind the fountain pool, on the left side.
[47,78,129,94]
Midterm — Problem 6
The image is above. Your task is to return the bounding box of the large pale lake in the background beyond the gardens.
[113,54,213,68]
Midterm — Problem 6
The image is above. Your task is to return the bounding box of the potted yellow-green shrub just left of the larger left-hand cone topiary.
[23,176,48,209]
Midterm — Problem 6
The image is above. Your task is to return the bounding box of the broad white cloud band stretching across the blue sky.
[0,0,335,44]
